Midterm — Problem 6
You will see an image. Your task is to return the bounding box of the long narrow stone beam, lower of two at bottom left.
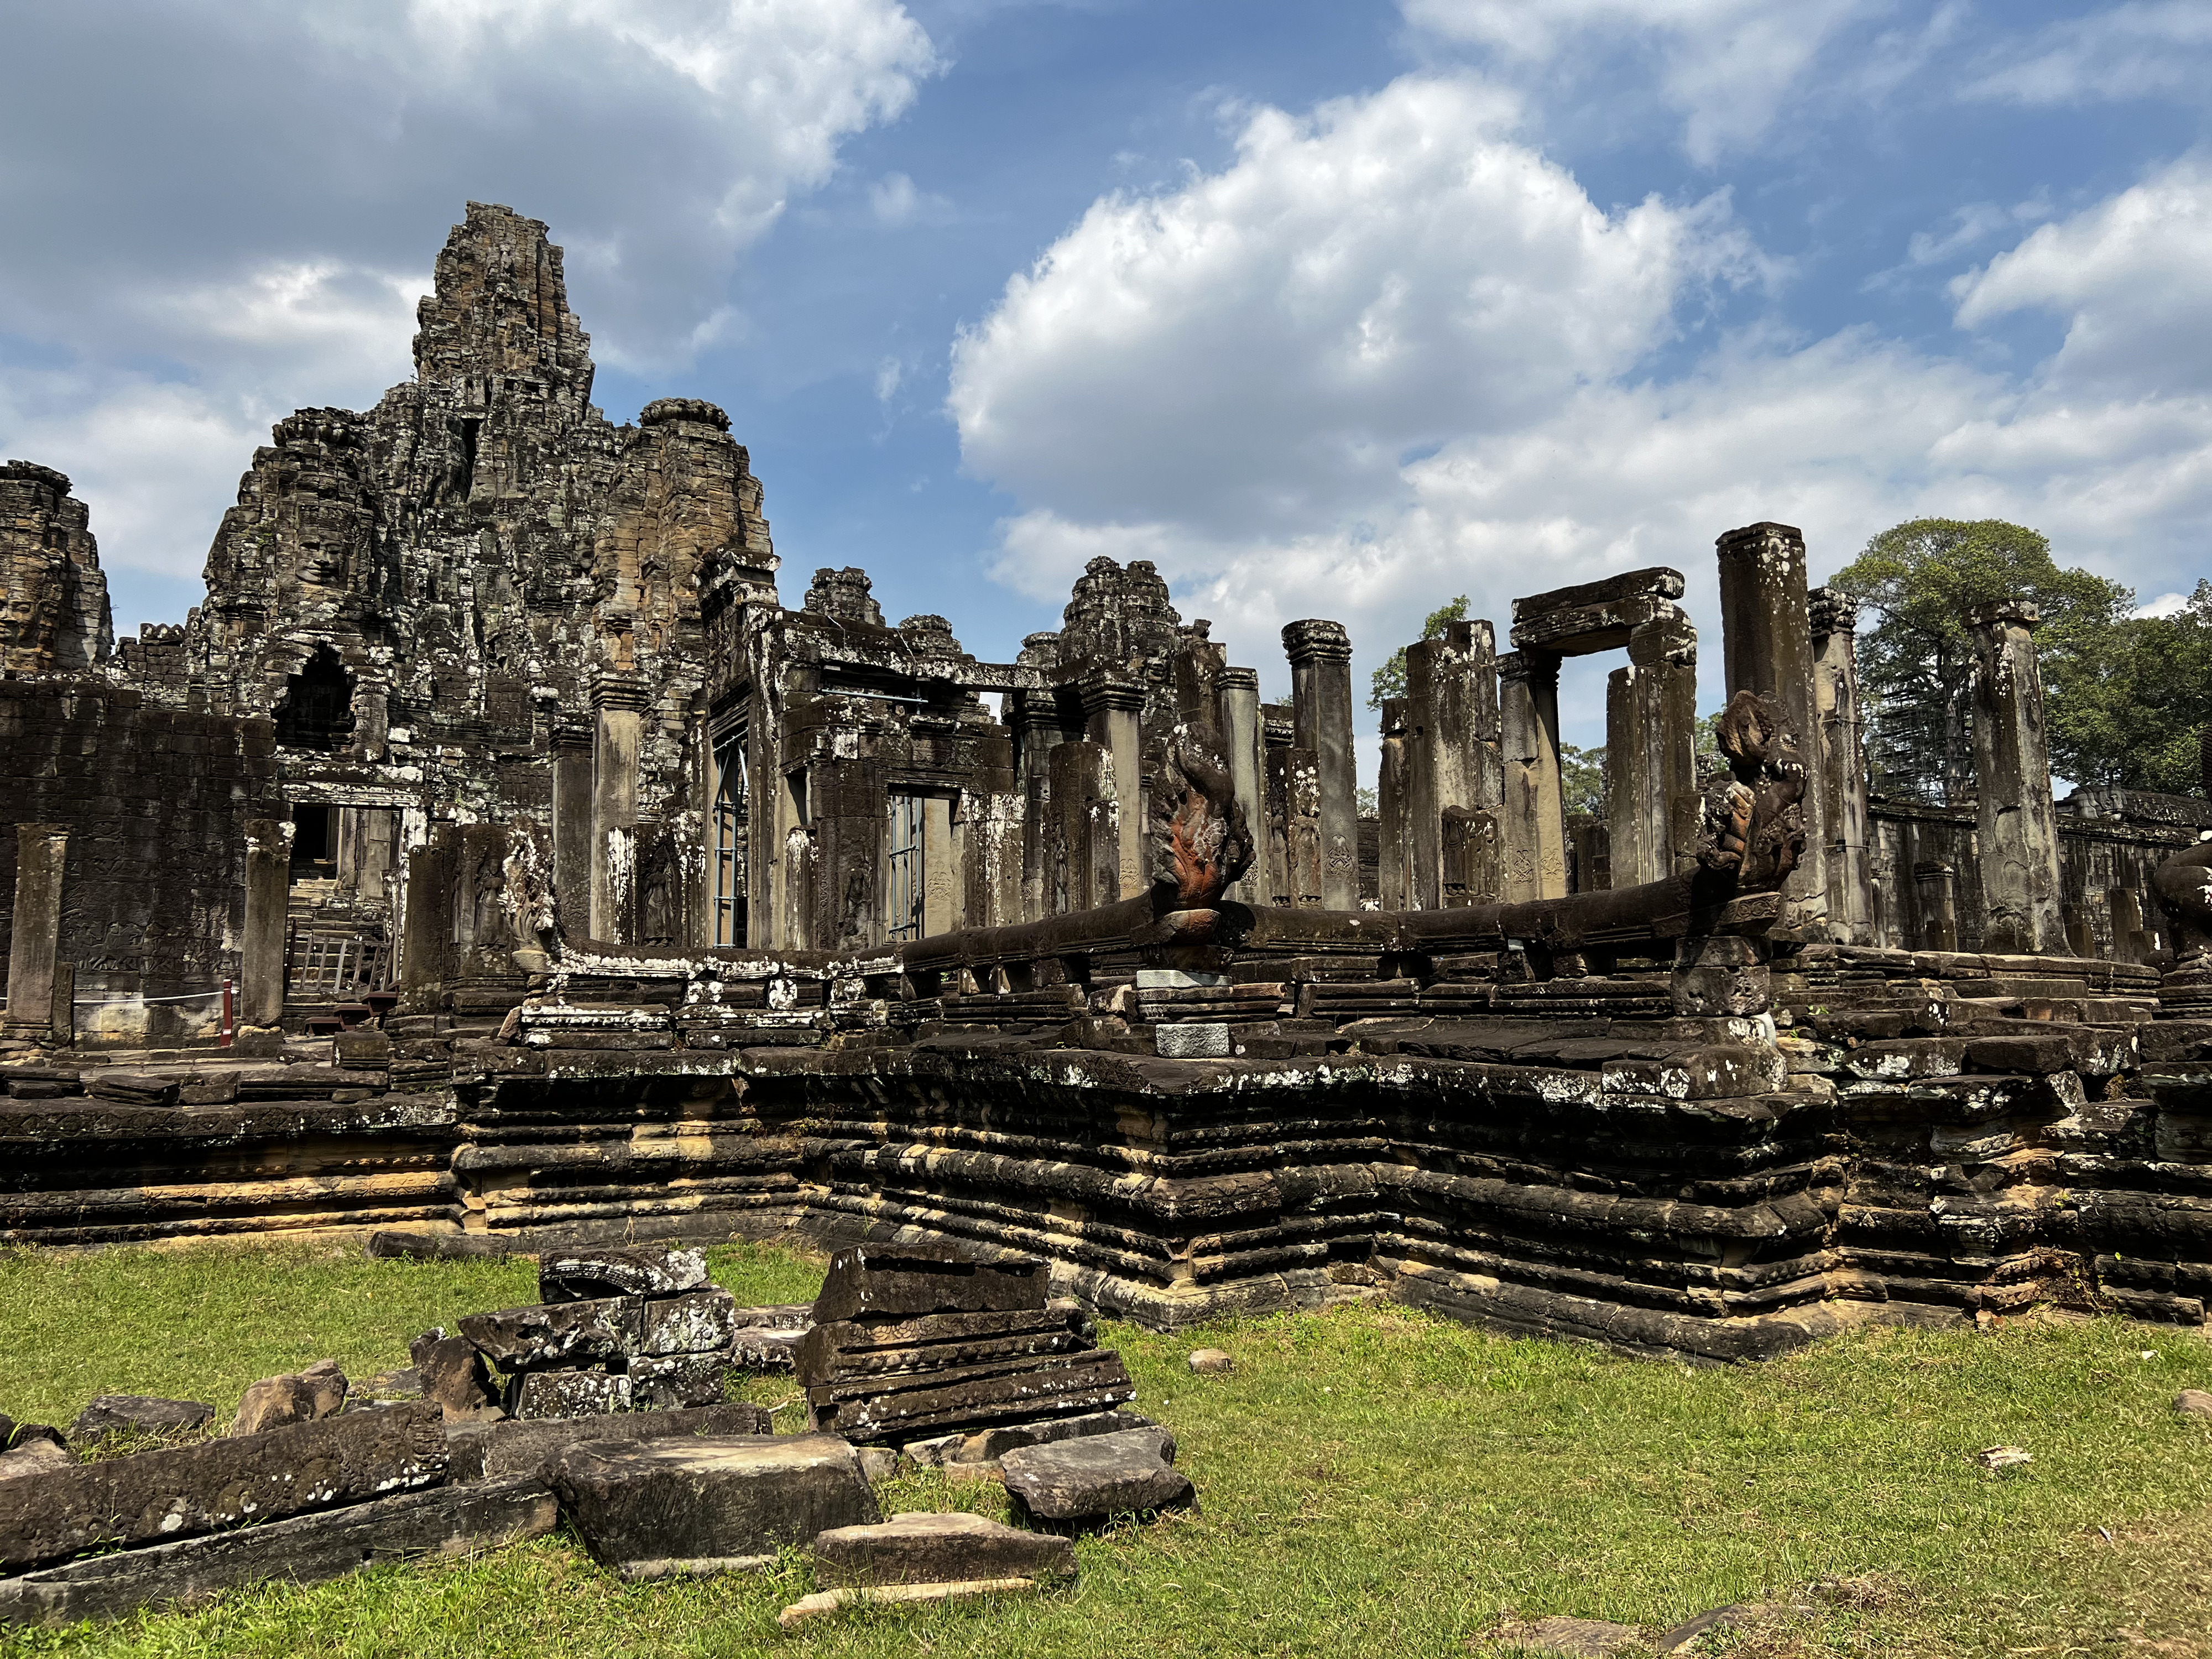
[0,1480,560,1626]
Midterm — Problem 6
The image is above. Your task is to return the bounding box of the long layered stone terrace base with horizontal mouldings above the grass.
[17,987,2212,1360]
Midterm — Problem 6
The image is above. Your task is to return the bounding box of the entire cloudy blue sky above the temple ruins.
[0,0,2212,765]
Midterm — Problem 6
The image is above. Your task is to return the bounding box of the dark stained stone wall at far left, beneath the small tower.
[0,679,276,1042]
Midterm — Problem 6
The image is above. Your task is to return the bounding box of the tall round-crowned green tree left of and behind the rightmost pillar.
[1829,518,2135,801]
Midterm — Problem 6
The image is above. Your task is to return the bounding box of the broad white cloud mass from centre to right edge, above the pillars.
[949,77,2212,734]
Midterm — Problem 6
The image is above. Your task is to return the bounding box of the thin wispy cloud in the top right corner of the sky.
[1964,0,2212,106]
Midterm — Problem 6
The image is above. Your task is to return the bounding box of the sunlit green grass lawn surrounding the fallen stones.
[0,1245,2212,1659]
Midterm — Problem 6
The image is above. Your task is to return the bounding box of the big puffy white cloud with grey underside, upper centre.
[949,77,1752,546]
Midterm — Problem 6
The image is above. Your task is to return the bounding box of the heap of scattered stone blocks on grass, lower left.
[0,1248,1192,1624]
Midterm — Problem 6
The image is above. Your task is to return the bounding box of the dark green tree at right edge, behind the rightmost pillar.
[2037,582,2212,794]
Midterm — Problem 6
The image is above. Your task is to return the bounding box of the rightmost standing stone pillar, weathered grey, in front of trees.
[1966,599,2066,956]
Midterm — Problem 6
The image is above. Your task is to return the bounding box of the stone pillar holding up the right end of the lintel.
[1606,619,1699,887]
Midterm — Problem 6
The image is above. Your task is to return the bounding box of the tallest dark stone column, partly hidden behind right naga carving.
[1717,522,1827,927]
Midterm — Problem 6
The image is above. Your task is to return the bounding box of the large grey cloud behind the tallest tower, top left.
[0,0,936,593]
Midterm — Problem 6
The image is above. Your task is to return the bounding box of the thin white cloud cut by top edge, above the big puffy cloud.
[1402,0,1909,166]
